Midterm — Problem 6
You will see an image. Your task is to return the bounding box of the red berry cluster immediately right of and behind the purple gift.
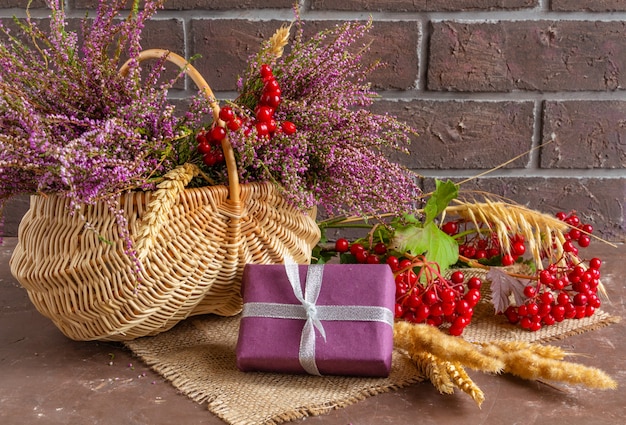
[335,238,482,336]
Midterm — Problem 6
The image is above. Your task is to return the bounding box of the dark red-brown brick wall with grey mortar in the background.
[0,0,626,241]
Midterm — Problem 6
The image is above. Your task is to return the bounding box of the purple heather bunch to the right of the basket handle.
[230,19,419,216]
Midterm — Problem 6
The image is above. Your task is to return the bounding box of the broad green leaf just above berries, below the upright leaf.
[392,221,459,271]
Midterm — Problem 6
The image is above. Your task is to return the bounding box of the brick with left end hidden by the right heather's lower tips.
[373,101,533,170]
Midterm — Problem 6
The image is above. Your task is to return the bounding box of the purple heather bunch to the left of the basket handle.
[0,0,207,256]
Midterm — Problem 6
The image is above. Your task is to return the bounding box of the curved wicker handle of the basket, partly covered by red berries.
[119,49,241,204]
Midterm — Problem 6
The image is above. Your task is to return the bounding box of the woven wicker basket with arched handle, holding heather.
[10,50,320,341]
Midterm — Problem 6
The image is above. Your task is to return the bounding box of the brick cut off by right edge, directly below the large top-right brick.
[541,101,626,168]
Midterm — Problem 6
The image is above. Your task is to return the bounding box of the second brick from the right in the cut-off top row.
[311,0,538,12]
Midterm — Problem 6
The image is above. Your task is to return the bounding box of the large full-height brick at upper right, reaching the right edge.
[428,21,626,92]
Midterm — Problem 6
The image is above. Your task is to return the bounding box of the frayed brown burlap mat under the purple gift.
[126,294,618,425]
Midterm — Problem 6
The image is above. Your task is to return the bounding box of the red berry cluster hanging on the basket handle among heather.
[196,65,296,166]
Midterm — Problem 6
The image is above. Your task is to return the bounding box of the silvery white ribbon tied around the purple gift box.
[242,262,393,375]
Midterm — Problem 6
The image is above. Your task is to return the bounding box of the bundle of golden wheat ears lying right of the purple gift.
[394,321,617,407]
